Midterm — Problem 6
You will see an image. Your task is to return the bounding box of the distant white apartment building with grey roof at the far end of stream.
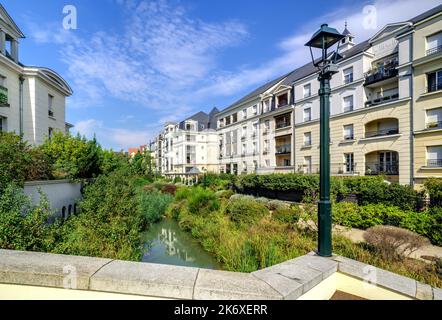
[151,108,219,178]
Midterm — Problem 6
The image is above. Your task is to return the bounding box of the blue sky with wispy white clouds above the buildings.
[1,0,440,150]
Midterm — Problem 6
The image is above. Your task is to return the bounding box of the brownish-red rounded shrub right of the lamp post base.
[364,226,429,260]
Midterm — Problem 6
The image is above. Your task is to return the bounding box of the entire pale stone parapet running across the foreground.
[0,250,442,300]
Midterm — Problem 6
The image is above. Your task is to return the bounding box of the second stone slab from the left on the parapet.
[90,261,199,299]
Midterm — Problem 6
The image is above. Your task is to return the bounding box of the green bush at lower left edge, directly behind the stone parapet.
[0,183,50,251]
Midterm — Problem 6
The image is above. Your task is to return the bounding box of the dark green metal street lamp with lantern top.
[305,24,345,257]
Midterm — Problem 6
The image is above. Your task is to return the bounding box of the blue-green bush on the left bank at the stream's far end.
[140,192,173,224]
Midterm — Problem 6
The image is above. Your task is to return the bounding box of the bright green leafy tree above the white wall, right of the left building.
[41,132,102,179]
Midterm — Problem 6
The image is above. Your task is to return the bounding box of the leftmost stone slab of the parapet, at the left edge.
[0,250,112,290]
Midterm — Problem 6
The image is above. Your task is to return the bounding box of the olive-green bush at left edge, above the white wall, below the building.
[0,132,31,193]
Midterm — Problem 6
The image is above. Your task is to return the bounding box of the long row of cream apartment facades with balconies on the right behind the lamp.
[152,6,442,186]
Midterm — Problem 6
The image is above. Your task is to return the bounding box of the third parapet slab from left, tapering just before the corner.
[194,269,283,300]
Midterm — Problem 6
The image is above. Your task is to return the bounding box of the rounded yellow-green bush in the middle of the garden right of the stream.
[226,198,269,224]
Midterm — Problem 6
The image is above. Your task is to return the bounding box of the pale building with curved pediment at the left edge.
[0,4,72,145]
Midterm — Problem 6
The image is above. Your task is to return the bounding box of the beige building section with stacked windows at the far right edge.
[410,10,442,187]
